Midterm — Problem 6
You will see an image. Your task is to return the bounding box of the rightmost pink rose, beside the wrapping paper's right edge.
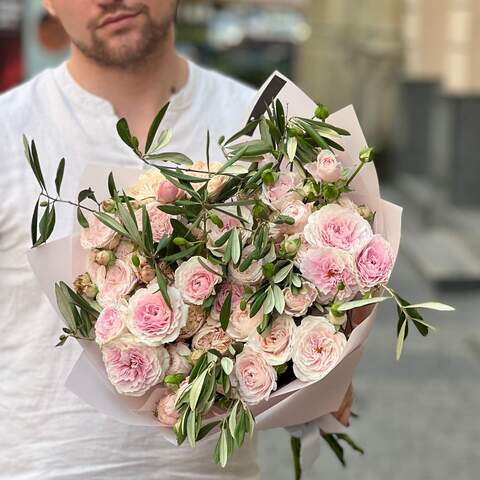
[355,235,395,291]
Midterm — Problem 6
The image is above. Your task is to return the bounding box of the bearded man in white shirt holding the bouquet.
[0,0,258,480]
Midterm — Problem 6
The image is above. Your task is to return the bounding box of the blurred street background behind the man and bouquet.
[0,0,480,480]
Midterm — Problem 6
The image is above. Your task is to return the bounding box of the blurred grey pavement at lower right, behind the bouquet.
[259,251,480,480]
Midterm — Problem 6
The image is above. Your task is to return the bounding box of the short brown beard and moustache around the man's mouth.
[72,5,176,70]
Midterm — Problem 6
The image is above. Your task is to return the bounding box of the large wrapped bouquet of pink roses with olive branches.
[25,74,450,476]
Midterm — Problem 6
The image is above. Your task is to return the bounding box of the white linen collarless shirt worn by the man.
[0,62,259,480]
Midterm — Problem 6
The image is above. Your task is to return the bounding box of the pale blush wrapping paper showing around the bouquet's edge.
[28,72,401,450]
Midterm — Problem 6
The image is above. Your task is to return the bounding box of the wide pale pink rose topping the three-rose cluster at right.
[303,203,373,253]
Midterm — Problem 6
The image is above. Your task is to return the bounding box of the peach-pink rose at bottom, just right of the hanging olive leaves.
[234,346,277,405]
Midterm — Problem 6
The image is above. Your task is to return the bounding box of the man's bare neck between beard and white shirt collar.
[68,31,188,145]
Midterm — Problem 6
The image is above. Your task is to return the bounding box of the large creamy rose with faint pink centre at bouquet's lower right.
[292,316,347,382]
